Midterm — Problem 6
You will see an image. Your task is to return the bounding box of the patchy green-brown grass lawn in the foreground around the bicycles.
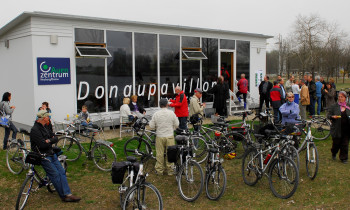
[0,127,350,210]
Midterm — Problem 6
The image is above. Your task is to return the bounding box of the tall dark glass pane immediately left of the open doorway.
[202,38,218,102]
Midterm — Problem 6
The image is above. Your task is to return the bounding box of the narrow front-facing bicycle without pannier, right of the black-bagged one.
[205,148,227,200]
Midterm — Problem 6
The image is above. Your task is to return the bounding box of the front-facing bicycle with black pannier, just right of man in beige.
[167,134,204,202]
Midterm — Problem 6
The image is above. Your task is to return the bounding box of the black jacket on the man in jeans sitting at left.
[30,122,58,155]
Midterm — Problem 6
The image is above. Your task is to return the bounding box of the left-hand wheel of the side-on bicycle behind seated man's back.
[56,136,81,161]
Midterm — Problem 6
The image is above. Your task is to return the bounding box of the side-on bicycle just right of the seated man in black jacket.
[56,124,117,171]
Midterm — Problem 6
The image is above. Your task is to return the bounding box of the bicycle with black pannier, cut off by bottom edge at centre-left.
[112,154,163,210]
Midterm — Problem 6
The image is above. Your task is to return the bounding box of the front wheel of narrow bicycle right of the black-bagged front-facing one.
[205,165,227,200]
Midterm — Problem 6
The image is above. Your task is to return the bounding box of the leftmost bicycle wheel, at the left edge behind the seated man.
[6,143,24,174]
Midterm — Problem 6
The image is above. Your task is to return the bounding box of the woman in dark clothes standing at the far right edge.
[327,91,350,164]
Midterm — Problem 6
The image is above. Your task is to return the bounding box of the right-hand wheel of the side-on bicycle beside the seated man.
[91,143,117,171]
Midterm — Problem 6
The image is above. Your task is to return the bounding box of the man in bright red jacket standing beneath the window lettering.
[169,86,188,130]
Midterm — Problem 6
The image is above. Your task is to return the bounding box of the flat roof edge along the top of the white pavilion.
[0,11,273,39]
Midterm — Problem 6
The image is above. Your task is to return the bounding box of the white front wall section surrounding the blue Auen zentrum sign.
[32,35,76,121]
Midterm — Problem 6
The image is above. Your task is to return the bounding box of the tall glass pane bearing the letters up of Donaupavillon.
[135,33,158,108]
